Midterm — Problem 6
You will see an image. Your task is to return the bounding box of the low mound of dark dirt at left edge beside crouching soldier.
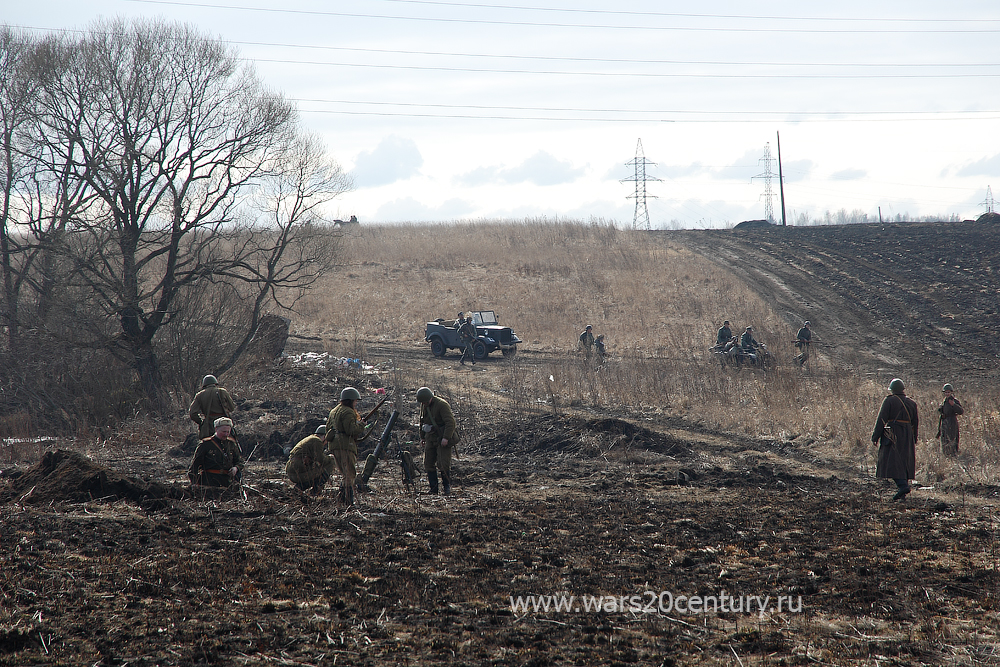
[0,449,183,504]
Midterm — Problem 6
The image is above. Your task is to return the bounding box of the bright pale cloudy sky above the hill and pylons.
[7,0,1000,228]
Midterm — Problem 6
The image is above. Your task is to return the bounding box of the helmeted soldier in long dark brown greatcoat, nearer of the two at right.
[872,378,919,500]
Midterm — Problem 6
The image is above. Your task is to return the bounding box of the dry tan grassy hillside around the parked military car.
[284,221,1000,488]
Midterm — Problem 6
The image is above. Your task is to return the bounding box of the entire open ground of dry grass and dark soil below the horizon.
[0,220,1000,667]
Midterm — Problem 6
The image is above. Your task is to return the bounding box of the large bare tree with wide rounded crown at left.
[26,21,350,410]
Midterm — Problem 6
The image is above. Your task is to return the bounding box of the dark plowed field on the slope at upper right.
[670,222,1000,381]
